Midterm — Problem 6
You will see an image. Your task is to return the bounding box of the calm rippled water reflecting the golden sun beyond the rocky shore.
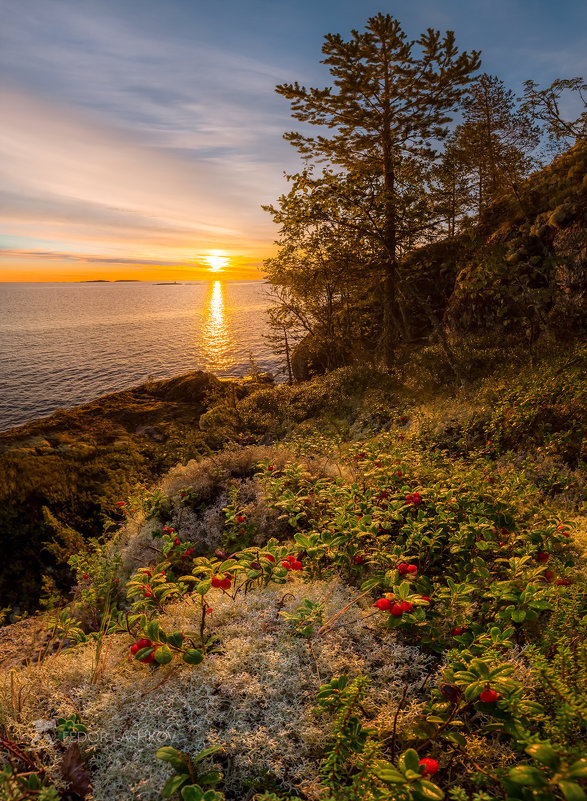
[0,280,277,431]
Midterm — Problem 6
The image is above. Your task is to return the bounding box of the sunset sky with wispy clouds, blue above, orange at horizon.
[0,0,587,281]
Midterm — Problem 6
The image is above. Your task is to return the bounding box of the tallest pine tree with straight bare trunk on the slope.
[277,14,479,367]
